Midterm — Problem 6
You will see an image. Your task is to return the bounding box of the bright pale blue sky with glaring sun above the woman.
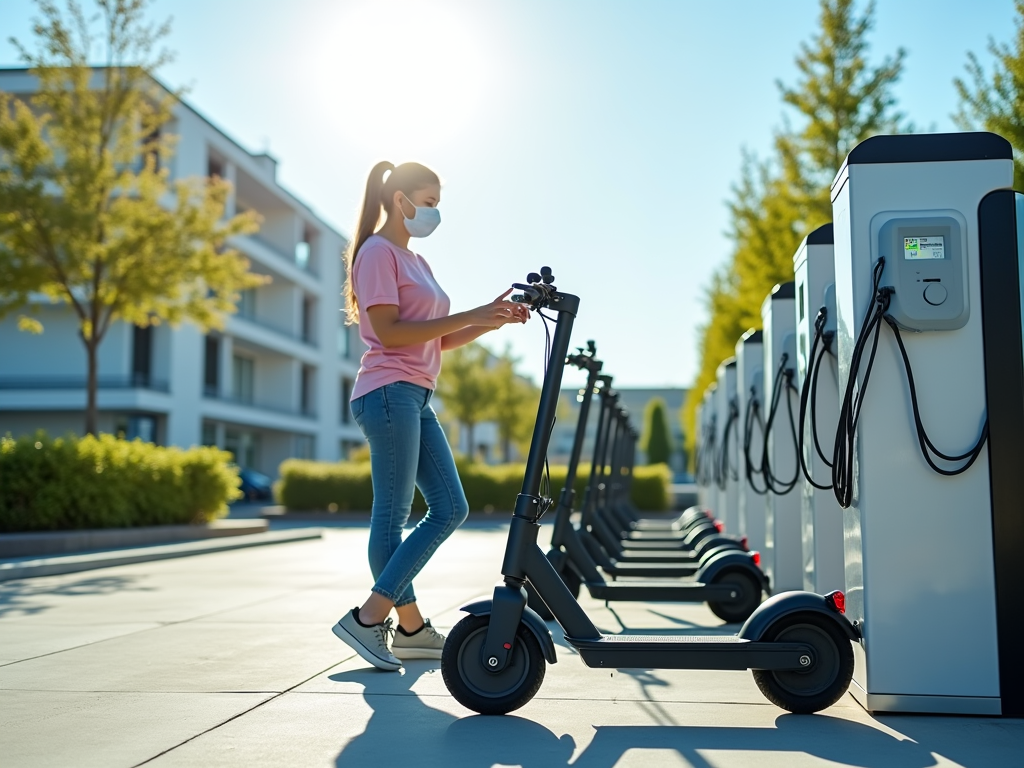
[0,0,1014,386]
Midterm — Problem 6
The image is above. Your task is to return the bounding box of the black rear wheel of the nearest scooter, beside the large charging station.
[753,613,853,715]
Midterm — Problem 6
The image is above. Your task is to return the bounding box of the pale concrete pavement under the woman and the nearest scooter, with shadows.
[0,521,1024,768]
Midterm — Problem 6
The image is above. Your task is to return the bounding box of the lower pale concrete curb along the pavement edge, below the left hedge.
[0,528,323,582]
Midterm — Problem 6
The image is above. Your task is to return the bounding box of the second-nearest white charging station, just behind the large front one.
[793,223,846,595]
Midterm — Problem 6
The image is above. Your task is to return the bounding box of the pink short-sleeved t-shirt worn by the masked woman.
[352,234,452,400]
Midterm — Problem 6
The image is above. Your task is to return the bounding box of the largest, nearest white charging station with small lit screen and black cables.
[831,133,1024,716]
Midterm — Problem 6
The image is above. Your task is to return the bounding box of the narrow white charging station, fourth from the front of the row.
[736,330,765,552]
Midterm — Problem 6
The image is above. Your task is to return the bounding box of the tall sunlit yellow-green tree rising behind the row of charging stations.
[682,0,904,456]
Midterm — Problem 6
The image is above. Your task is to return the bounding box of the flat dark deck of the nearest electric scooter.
[565,635,814,670]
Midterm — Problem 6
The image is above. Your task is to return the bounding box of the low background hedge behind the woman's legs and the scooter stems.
[274,459,672,512]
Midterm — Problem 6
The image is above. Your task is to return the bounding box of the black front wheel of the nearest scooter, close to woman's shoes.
[441,615,547,715]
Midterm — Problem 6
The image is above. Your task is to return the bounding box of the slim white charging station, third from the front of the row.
[761,283,804,592]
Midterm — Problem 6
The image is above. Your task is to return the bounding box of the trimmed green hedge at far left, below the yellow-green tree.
[0,432,242,532]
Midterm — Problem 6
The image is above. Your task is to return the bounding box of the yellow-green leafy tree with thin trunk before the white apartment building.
[0,0,265,434]
